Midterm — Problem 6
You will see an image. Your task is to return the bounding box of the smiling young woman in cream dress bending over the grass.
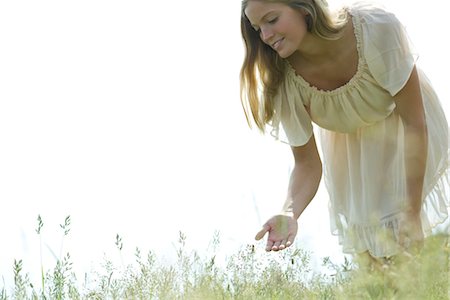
[241,0,450,258]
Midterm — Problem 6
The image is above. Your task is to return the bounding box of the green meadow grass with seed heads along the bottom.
[0,217,450,300]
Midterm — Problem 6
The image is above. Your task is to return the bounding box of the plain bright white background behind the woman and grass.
[0,0,450,285]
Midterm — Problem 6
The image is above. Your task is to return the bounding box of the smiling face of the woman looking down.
[245,0,308,58]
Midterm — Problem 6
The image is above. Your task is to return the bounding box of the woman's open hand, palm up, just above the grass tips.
[255,214,298,251]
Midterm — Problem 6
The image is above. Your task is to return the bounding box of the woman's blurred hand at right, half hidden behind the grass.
[399,212,424,254]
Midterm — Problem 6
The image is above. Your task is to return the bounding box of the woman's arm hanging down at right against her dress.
[394,67,428,246]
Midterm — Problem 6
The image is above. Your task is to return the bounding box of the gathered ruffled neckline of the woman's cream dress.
[285,7,363,95]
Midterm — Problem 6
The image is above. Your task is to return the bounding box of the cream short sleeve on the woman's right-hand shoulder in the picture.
[359,8,418,96]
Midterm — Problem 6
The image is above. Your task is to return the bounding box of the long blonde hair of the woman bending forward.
[240,0,347,132]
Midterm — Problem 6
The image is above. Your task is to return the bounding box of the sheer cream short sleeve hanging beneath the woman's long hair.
[269,78,313,146]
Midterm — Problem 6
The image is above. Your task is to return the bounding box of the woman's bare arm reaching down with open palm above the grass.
[256,136,322,251]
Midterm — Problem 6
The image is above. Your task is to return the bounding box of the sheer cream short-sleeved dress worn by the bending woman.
[270,3,450,257]
